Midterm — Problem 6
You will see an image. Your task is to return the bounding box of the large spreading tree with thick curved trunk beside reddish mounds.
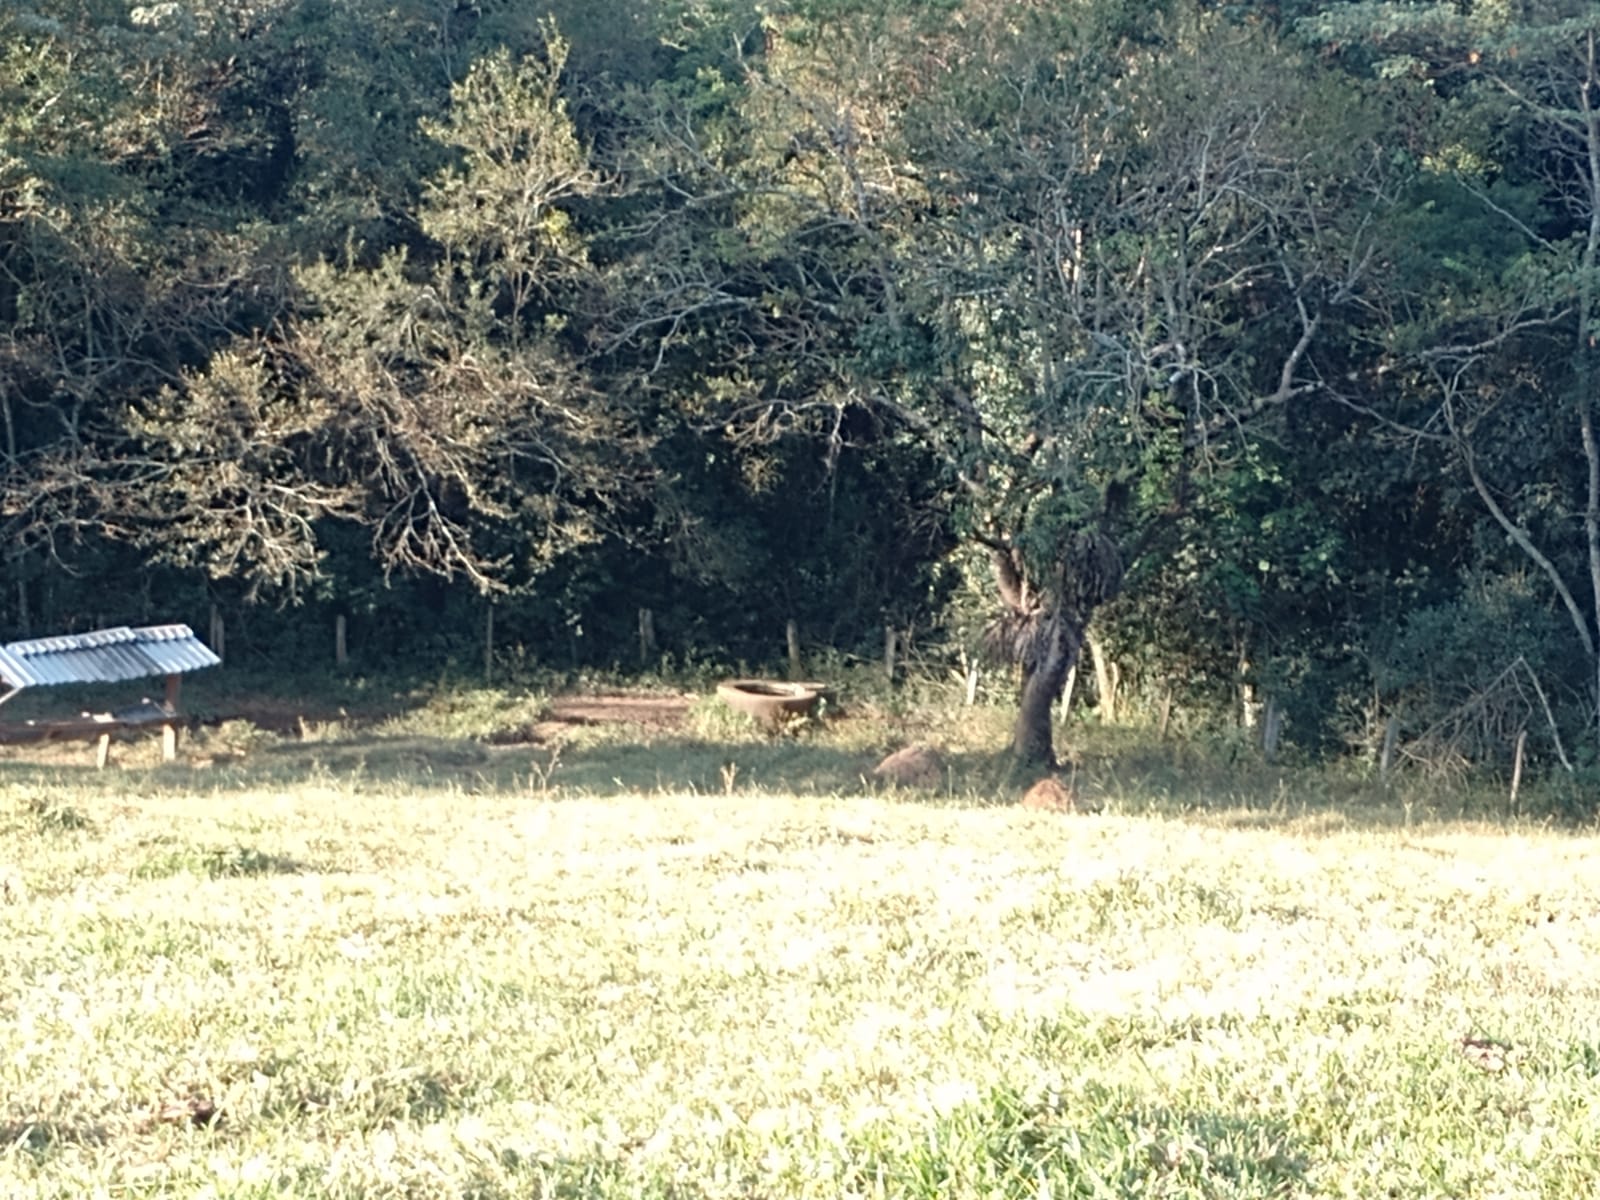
[626,3,1382,762]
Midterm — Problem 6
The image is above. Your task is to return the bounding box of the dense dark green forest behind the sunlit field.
[0,0,1600,774]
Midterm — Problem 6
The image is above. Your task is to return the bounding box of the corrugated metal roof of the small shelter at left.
[0,626,222,688]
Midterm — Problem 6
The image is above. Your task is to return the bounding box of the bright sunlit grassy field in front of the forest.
[0,698,1600,1200]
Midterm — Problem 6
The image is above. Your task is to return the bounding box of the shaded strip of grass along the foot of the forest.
[0,710,1555,835]
